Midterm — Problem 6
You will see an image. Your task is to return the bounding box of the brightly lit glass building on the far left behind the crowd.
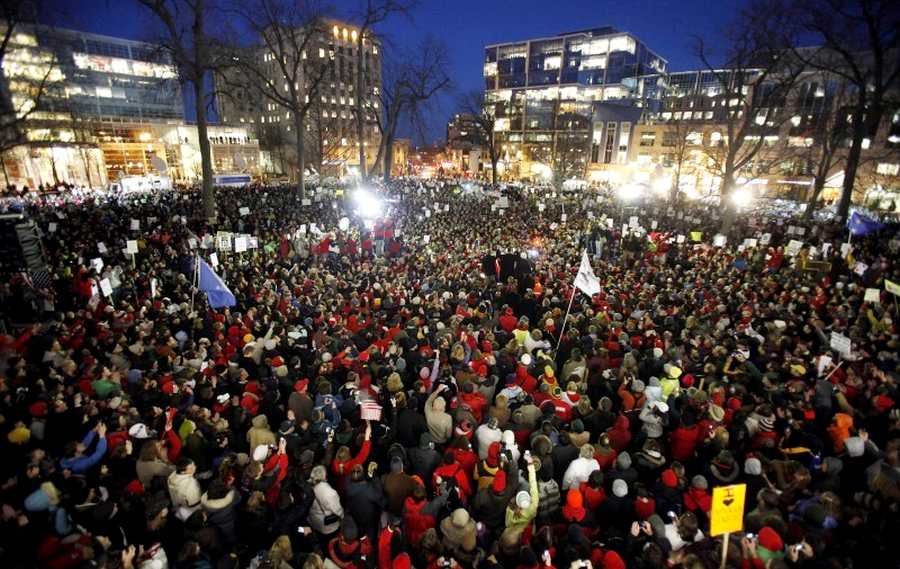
[2,25,184,187]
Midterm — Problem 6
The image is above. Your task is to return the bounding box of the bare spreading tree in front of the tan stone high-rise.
[219,0,334,196]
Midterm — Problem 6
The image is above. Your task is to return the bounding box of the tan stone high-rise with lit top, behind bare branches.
[216,20,382,175]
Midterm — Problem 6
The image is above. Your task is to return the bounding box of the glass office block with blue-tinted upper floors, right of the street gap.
[484,26,666,180]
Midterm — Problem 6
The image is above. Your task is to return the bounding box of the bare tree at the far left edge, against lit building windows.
[0,0,59,157]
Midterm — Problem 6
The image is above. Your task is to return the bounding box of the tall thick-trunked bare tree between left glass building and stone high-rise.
[138,0,219,221]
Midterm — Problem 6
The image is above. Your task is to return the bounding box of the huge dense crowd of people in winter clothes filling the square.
[0,179,900,569]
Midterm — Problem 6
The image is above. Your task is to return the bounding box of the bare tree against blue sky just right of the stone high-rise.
[367,37,451,181]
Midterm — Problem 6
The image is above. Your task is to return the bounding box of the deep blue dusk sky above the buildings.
[45,0,744,143]
